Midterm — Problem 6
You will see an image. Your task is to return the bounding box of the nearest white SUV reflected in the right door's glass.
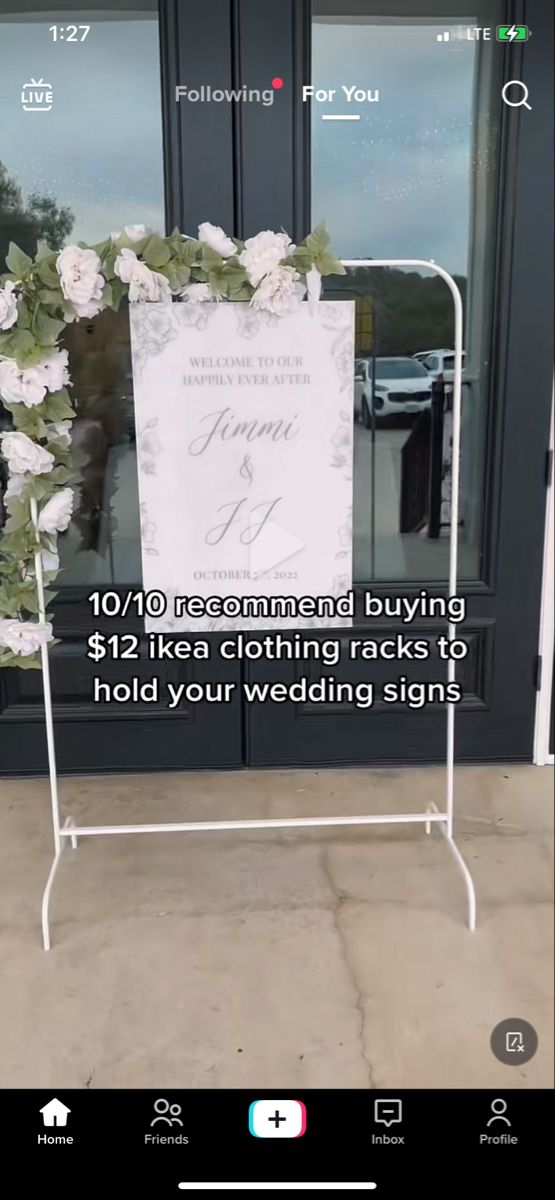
[354,358,432,428]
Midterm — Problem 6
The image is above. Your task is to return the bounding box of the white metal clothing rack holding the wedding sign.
[31,258,476,950]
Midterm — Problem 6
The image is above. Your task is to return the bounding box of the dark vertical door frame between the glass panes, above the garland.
[160,0,310,239]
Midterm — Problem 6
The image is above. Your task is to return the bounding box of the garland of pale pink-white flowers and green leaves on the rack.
[0,222,345,667]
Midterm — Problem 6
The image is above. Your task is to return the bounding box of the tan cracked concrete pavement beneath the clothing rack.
[0,766,553,1090]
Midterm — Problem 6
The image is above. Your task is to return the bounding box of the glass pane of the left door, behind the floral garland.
[0,0,165,584]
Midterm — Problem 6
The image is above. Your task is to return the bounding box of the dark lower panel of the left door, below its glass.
[0,637,241,775]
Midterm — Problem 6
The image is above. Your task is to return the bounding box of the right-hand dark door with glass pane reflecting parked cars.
[250,0,551,763]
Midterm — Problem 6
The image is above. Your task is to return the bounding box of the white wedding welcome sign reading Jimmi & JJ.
[130,301,354,632]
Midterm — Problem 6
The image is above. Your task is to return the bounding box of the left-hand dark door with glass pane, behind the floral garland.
[0,0,241,773]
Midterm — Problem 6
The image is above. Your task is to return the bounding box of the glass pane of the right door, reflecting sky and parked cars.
[311,0,502,582]
